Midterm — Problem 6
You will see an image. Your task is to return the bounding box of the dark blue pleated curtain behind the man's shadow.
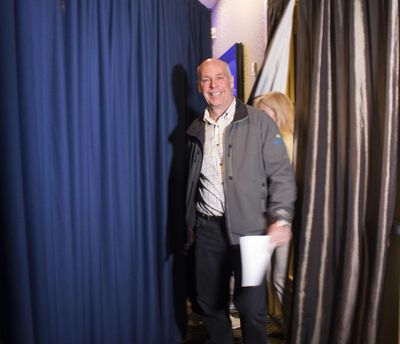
[0,0,211,344]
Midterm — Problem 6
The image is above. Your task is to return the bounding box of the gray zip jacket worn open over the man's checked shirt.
[186,99,296,245]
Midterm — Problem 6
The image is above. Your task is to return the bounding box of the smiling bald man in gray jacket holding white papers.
[186,59,295,344]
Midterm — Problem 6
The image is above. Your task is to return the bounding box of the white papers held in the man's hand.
[239,235,275,287]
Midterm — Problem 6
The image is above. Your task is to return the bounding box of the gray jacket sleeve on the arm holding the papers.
[260,116,296,222]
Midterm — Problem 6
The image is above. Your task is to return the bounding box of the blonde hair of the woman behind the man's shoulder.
[253,92,294,135]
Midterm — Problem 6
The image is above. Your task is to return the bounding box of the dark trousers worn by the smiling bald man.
[195,217,267,344]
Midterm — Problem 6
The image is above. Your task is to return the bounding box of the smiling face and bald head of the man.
[198,60,233,114]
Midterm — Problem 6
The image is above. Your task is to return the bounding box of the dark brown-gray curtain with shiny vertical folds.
[290,0,399,344]
